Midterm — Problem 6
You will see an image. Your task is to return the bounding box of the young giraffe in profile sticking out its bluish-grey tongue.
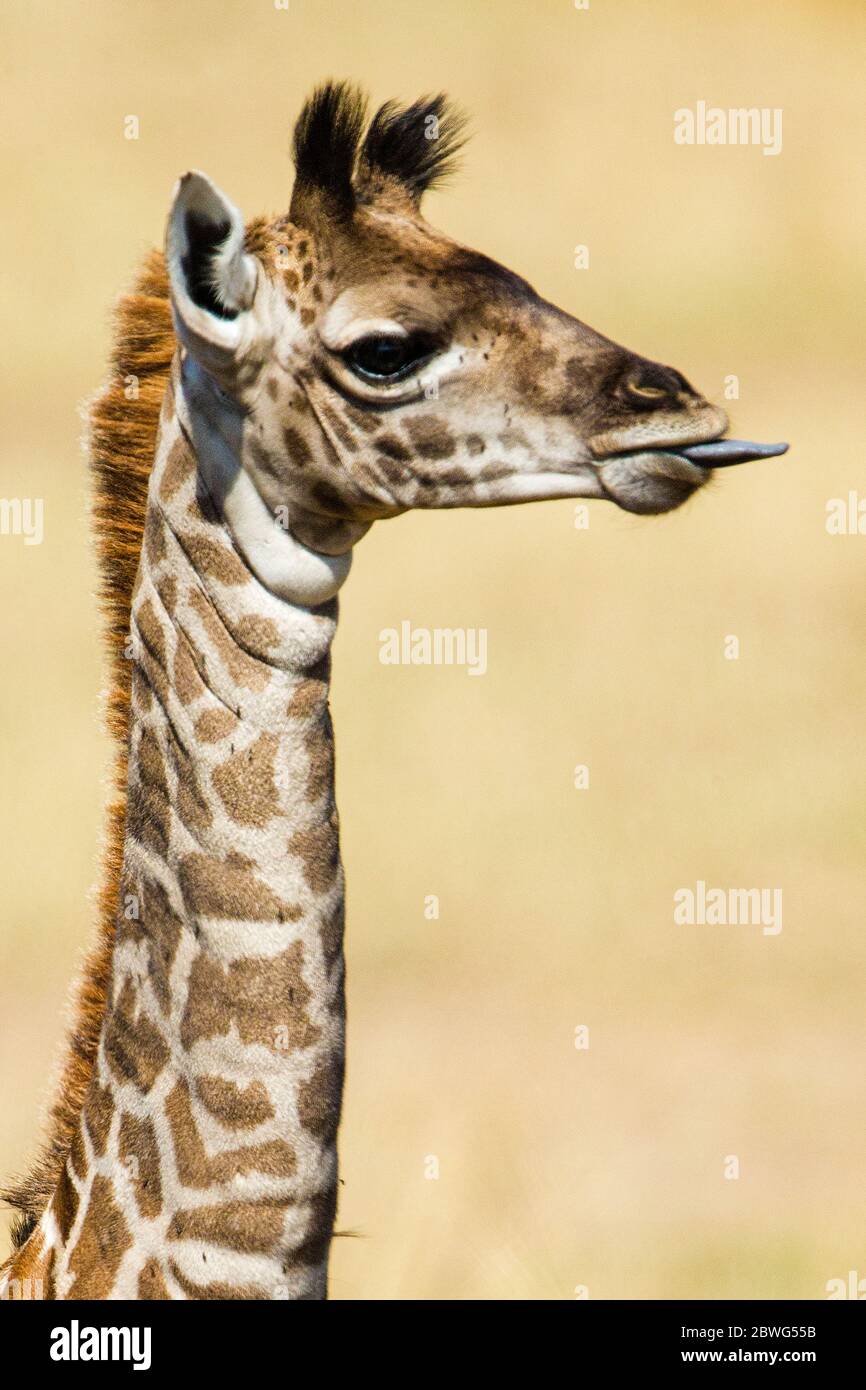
[3,82,784,1300]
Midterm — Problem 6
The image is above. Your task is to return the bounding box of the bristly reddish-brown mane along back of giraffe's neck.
[0,252,175,1247]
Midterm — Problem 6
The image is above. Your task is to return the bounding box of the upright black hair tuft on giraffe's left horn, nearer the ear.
[293,82,367,209]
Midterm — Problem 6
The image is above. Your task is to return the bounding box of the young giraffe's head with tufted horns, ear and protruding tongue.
[167,83,781,555]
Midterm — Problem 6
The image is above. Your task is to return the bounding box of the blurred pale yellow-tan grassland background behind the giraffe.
[0,0,866,1300]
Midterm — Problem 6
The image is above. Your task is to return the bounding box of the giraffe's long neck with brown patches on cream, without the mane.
[43,364,348,1298]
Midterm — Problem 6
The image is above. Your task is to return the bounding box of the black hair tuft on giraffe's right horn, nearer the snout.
[361,92,466,202]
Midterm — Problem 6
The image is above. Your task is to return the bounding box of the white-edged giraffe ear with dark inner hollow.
[165,171,257,359]
